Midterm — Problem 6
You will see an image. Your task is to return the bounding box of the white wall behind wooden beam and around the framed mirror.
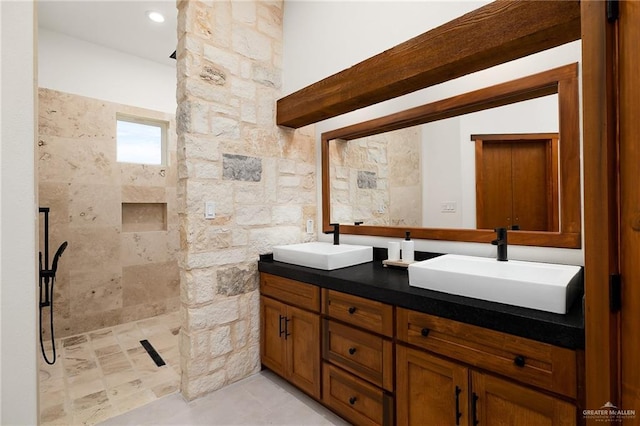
[283,1,584,264]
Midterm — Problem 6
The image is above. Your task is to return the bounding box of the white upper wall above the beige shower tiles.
[38,28,177,114]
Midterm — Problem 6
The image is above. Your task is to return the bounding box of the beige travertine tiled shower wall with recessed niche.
[37,89,180,338]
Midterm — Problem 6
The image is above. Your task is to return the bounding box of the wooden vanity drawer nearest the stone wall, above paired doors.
[260,273,320,312]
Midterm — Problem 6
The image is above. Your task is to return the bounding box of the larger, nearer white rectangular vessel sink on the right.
[409,254,581,314]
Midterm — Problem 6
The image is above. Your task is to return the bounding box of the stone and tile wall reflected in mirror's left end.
[329,126,422,226]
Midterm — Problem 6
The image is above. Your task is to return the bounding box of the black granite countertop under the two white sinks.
[258,250,584,349]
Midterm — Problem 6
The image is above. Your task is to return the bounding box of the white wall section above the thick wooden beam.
[283,0,490,95]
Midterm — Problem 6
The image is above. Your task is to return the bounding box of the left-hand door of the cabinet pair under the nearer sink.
[396,345,468,426]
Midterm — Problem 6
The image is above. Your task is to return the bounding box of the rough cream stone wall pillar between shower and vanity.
[177,0,317,399]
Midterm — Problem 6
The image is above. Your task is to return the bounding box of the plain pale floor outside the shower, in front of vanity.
[100,370,349,426]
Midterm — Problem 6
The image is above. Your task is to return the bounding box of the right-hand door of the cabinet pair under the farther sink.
[285,306,320,399]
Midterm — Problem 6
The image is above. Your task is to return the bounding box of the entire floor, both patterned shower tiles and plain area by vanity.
[39,313,349,426]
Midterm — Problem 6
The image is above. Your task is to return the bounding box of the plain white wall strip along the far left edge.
[0,1,38,425]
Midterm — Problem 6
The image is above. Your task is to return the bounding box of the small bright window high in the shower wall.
[116,116,167,165]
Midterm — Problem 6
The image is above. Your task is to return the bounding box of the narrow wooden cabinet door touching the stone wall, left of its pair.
[260,296,286,376]
